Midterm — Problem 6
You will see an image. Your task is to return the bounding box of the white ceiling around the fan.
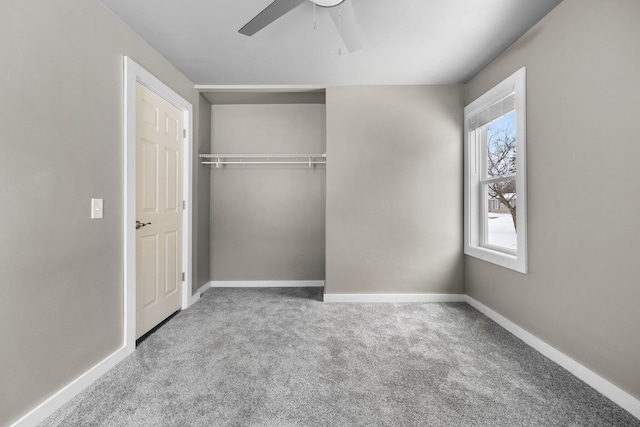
[102,0,561,86]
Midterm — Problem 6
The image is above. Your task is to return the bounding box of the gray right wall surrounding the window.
[466,0,640,398]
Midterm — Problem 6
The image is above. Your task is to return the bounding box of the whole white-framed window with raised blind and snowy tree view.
[464,68,527,273]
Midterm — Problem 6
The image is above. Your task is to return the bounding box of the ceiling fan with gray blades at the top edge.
[238,0,362,52]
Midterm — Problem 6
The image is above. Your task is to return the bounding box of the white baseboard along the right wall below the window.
[467,295,640,419]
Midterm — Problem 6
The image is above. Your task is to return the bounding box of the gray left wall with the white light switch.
[0,0,207,425]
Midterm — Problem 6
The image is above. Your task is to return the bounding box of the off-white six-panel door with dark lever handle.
[136,83,184,339]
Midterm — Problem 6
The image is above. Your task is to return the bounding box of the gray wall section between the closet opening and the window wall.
[325,86,464,294]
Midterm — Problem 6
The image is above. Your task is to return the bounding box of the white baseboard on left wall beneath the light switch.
[11,347,134,427]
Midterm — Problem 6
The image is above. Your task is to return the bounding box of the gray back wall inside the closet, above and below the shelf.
[211,104,325,280]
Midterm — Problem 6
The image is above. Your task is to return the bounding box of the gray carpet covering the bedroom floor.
[41,288,640,427]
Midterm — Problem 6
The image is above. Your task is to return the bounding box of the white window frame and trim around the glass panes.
[464,68,527,274]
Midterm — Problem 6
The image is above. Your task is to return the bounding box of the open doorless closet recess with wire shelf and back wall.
[198,88,330,299]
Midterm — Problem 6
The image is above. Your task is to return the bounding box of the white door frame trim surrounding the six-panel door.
[123,56,195,351]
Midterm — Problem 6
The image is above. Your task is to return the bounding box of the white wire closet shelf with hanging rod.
[200,154,327,168]
